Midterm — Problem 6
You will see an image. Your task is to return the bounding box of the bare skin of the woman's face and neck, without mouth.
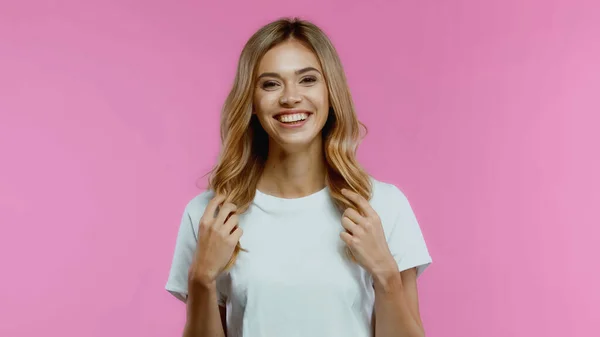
[253,40,329,198]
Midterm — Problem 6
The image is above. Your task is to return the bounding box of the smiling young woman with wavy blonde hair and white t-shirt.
[166,19,431,337]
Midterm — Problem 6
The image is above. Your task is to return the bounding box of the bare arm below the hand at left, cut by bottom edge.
[183,282,227,337]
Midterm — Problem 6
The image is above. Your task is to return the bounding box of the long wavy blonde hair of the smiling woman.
[208,18,372,269]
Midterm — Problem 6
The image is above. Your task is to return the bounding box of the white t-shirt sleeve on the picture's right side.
[388,186,432,277]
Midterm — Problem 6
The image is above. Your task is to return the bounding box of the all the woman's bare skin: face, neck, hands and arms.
[184,40,424,337]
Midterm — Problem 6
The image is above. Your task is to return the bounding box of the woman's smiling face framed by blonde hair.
[253,40,329,151]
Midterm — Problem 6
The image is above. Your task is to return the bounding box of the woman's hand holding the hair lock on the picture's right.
[340,189,398,275]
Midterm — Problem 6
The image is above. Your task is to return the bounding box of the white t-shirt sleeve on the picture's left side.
[165,198,225,306]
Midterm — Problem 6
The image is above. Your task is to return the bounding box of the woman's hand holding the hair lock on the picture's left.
[188,195,242,287]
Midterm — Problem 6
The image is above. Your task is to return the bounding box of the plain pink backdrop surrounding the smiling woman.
[0,0,600,337]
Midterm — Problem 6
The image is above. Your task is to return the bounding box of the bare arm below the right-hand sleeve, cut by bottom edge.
[373,268,425,337]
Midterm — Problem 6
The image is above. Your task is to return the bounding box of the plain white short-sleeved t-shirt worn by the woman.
[165,179,432,337]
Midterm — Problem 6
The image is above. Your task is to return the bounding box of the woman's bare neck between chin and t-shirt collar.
[257,138,326,198]
